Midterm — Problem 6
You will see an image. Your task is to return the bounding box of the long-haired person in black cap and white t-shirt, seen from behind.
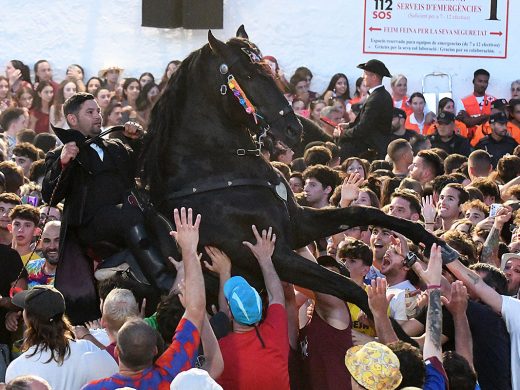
[6,286,118,390]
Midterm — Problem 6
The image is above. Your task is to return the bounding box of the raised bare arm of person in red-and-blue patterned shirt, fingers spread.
[170,207,206,331]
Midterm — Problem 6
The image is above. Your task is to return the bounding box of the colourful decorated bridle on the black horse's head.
[219,56,292,157]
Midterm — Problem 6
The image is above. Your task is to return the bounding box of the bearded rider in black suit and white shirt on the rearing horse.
[42,93,173,291]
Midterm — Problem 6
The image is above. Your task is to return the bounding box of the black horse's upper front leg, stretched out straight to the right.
[291,206,459,262]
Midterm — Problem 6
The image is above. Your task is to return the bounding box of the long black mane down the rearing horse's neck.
[139,45,209,196]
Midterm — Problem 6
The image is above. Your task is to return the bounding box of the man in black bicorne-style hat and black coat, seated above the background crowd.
[339,60,394,159]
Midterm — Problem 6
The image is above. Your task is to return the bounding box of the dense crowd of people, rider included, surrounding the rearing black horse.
[0,56,520,390]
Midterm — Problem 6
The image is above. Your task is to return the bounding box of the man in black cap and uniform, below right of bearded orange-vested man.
[475,112,518,169]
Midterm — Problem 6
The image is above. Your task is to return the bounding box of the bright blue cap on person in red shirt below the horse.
[224,276,262,325]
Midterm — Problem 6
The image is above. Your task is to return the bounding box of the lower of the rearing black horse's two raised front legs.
[273,248,371,316]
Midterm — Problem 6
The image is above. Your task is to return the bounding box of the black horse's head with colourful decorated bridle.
[208,26,302,147]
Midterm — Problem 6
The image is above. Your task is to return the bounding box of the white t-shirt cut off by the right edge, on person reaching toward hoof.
[502,295,520,390]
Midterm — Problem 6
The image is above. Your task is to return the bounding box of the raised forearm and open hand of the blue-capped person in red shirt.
[243,225,285,307]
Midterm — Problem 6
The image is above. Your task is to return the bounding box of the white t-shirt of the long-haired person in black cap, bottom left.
[5,340,119,390]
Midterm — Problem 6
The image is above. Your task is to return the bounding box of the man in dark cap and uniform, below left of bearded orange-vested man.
[429,111,471,157]
